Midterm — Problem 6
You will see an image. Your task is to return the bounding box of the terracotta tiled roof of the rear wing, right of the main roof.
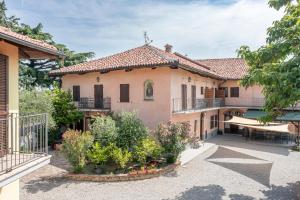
[197,58,248,80]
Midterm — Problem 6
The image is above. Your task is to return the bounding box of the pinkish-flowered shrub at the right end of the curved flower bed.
[155,122,189,163]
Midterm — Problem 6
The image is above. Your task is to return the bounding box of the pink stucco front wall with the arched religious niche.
[62,67,171,128]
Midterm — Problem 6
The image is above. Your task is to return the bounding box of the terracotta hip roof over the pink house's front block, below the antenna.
[50,45,221,78]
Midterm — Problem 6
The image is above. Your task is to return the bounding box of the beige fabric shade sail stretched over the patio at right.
[225,116,292,133]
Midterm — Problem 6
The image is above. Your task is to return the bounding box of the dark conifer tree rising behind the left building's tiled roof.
[0,1,95,89]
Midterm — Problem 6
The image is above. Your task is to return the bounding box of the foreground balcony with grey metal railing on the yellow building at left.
[0,114,50,177]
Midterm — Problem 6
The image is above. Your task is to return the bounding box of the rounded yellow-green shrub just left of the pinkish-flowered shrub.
[134,137,162,166]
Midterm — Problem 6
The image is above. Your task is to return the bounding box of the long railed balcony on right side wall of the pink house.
[172,98,224,113]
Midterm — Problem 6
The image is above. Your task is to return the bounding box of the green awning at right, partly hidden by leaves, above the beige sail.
[244,110,300,121]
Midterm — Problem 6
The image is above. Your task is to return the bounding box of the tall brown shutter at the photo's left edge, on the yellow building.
[0,54,8,156]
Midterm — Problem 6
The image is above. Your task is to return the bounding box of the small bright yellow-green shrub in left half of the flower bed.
[87,142,108,165]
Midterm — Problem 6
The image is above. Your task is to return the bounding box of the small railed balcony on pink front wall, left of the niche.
[77,97,111,111]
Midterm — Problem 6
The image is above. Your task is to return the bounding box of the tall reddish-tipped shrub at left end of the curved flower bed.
[63,130,93,172]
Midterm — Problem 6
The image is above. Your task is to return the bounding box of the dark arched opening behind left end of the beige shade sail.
[224,109,244,134]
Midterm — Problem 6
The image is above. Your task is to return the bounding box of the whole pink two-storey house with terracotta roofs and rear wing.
[50,45,298,140]
